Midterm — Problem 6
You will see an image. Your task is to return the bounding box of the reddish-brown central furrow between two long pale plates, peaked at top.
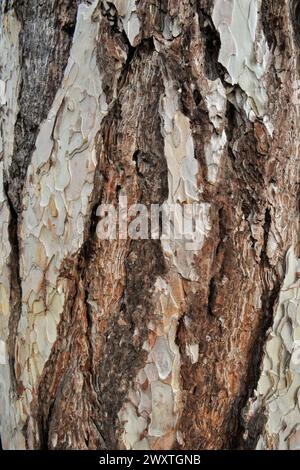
[35,39,168,449]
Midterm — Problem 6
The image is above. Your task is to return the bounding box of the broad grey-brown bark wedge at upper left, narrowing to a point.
[8,0,79,214]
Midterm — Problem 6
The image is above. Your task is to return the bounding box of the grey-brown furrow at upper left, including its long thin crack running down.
[5,0,77,404]
